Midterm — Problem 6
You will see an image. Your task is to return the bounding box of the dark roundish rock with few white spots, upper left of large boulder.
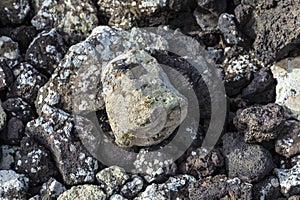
[26,29,67,74]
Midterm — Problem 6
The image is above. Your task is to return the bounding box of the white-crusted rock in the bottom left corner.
[0,170,28,200]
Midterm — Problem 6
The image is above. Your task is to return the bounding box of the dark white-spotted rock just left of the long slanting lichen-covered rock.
[15,137,58,186]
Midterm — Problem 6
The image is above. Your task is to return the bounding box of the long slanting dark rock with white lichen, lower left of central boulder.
[26,105,98,185]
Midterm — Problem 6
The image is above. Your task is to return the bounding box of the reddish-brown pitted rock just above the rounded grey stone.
[233,103,285,142]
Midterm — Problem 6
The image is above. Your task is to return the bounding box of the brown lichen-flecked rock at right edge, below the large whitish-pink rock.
[275,120,300,158]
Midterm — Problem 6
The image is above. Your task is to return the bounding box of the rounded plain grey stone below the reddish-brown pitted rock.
[222,133,274,182]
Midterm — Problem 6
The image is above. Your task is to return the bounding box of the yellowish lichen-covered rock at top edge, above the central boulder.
[98,0,168,29]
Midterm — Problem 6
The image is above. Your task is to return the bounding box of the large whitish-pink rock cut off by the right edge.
[271,57,300,119]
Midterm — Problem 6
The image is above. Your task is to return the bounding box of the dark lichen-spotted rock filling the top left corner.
[0,0,30,26]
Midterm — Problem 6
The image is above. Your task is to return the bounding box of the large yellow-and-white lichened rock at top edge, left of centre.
[31,0,98,42]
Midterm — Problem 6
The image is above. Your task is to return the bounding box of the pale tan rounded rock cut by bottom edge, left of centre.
[57,185,106,200]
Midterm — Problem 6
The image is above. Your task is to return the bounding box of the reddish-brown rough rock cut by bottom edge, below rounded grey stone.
[189,175,252,200]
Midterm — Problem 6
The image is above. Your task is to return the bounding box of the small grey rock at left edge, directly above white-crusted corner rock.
[0,145,20,170]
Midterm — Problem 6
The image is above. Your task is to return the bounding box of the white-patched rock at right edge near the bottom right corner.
[274,163,300,196]
